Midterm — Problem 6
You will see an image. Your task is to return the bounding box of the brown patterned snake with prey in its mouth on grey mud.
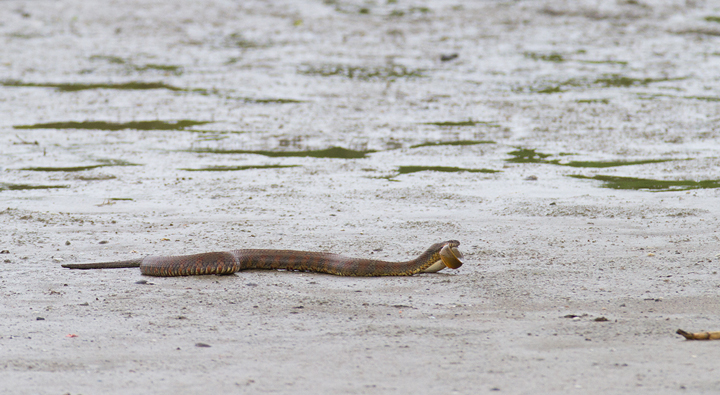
[62,240,464,277]
